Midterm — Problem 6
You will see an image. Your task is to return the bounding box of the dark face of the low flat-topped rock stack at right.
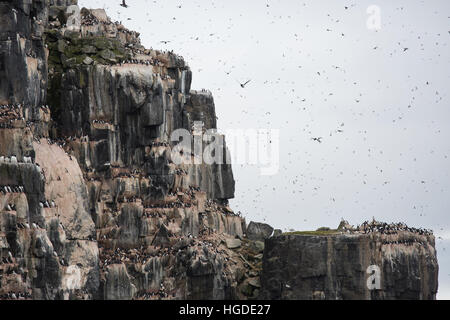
[261,231,438,300]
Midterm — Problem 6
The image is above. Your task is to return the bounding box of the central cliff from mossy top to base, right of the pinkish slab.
[46,1,239,299]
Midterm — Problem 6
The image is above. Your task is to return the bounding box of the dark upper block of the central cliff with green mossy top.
[46,9,234,200]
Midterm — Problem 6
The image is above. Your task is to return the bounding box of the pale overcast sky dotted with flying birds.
[79,0,450,299]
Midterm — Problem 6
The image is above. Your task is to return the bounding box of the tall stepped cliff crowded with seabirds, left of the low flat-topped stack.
[0,0,434,299]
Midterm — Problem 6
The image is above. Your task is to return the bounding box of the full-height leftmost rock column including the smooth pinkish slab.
[0,0,99,299]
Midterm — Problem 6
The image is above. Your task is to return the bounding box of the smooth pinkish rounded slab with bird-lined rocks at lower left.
[0,139,99,299]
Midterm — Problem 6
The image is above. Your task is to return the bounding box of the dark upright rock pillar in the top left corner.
[0,0,48,114]
